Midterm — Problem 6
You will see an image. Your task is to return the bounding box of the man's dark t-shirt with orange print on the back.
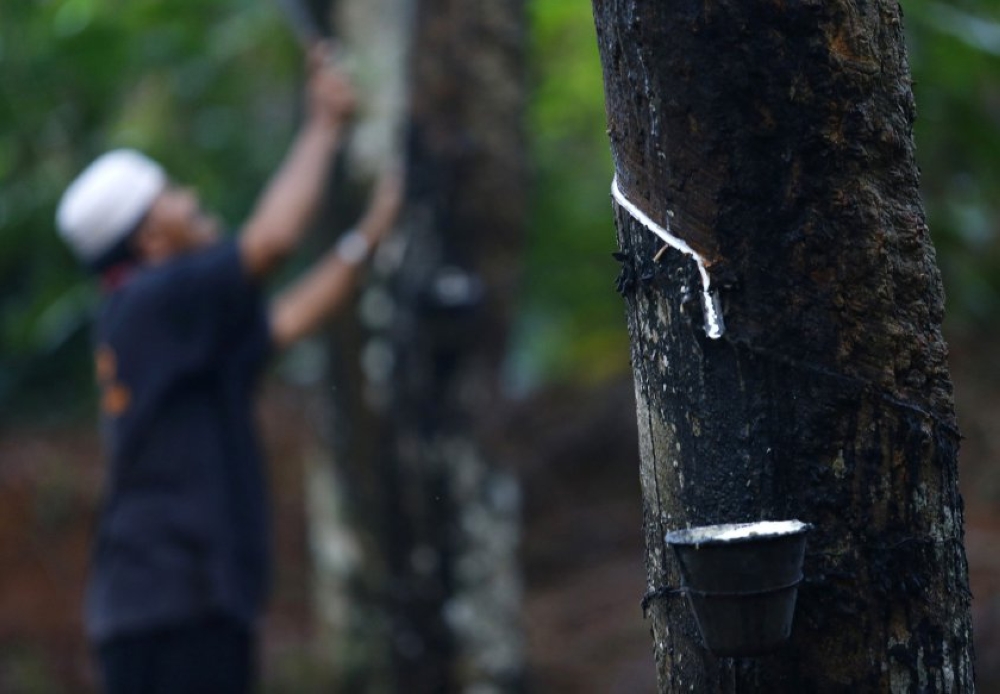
[86,242,270,641]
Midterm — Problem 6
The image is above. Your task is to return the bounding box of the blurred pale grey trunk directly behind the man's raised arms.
[301,0,413,693]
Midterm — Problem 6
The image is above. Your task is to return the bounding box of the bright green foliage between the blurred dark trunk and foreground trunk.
[515,0,628,392]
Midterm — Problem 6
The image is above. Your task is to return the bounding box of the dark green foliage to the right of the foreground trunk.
[906,0,1000,328]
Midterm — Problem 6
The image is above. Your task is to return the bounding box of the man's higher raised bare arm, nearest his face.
[239,45,355,277]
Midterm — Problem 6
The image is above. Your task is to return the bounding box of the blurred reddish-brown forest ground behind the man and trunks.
[0,339,1000,694]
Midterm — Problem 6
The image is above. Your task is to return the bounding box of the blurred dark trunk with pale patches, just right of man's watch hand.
[390,0,525,692]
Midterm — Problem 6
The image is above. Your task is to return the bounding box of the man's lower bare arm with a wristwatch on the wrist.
[270,169,402,349]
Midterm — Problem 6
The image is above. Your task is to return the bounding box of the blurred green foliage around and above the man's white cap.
[0,0,300,418]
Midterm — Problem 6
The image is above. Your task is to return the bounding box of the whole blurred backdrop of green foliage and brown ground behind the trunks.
[0,0,1000,694]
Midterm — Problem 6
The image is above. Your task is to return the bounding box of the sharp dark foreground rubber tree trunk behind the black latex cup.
[593,0,973,692]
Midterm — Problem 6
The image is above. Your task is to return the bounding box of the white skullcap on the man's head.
[56,149,167,262]
